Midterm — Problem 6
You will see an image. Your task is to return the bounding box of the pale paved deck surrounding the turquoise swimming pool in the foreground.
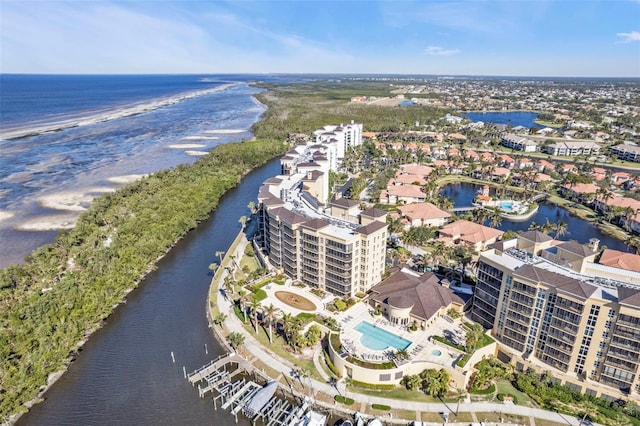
[337,303,464,367]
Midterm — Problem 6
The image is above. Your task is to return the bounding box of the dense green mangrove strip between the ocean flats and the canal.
[0,140,286,421]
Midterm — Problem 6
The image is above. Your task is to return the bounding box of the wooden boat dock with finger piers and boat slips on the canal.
[187,353,324,426]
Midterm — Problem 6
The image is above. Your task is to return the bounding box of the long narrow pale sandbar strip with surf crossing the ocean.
[0,83,240,140]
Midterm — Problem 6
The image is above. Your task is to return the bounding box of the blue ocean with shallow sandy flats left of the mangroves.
[0,74,279,267]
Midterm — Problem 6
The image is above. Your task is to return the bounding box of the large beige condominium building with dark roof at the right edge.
[471,231,640,399]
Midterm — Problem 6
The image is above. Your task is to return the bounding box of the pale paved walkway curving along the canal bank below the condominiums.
[216,230,592,426]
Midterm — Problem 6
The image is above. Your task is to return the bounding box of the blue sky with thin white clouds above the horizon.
[0,0,640,77]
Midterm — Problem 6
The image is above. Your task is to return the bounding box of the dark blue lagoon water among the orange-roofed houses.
[440,182,629,251]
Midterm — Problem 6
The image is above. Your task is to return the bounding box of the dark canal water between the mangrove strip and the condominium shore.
[18,160,280,426]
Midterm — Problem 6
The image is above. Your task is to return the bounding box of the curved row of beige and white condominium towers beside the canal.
[258,123,388,297]
